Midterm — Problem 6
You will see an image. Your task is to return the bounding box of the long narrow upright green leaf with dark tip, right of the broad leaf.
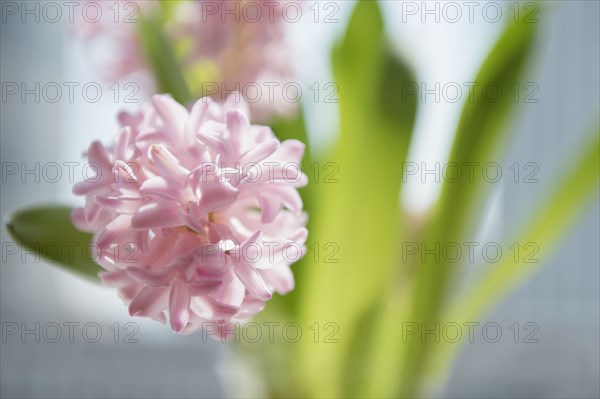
[364,10,535,397]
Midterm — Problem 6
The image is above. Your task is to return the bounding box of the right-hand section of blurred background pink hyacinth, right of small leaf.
[174,0,302,121]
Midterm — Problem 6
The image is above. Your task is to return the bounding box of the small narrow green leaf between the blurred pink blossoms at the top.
[138,15,193,105]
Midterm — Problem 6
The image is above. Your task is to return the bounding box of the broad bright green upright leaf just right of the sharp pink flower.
[298,1,416,397]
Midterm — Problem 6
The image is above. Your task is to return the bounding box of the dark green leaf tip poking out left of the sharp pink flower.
[6,206,102,281]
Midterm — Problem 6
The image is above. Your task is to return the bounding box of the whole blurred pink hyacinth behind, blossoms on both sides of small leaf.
[74,0,302,122]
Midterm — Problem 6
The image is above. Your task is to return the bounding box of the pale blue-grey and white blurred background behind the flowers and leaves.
[0,1,600,398]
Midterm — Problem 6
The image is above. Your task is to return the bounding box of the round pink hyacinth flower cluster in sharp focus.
[72,95,308,334]
